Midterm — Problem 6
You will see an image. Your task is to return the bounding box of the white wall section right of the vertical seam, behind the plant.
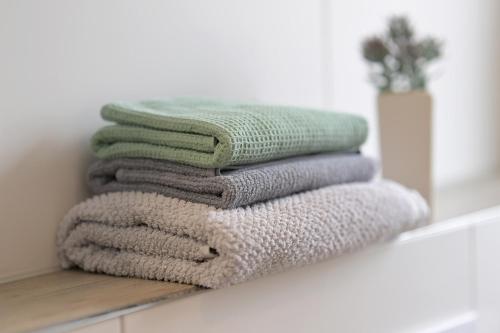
[325,0,500,186]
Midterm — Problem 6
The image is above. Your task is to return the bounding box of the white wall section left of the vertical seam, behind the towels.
[0,0,322,280]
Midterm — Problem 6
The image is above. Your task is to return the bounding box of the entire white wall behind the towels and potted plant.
[0,0,500,280]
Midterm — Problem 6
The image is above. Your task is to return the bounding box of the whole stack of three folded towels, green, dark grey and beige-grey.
[58,99,428,288]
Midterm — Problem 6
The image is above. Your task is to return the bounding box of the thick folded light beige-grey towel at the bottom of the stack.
[58,181,428,288]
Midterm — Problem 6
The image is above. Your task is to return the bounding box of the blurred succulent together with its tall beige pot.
[362,17,442,208]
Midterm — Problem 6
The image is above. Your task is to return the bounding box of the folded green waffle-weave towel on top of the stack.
[92,98,368,168]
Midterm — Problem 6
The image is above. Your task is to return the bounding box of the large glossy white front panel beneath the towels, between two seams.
[123,220,475,333]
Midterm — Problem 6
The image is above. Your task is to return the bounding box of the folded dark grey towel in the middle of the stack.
[88,154,376,208]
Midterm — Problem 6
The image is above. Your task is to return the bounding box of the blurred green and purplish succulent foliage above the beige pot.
[362,16,442,92]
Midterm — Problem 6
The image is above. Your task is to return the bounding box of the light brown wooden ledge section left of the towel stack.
[0,271,204,332]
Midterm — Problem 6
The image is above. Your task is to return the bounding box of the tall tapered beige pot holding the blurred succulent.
[378,91,432,207]
